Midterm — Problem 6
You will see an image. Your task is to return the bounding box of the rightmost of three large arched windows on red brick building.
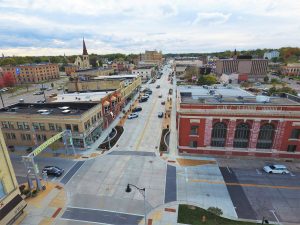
[256,123,275,149]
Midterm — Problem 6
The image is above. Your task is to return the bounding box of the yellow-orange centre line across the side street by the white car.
[190,179,300,190]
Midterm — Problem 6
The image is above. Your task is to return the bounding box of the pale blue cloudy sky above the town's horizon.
[0,0,300,56]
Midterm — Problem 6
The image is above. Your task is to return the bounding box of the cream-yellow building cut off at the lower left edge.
[0,129,26,225]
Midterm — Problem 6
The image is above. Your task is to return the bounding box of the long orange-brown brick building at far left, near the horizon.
[2,63,59,84]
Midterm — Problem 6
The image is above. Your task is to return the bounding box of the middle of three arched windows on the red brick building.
[233,123,250,148]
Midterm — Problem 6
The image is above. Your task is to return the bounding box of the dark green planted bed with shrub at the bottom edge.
[177,204,260,225]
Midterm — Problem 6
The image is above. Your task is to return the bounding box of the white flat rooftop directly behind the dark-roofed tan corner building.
[53,91,112,102]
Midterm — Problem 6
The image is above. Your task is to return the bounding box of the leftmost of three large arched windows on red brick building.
[211,122,227,147]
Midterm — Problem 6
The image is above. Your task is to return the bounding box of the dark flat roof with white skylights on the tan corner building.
[0,102,98,116]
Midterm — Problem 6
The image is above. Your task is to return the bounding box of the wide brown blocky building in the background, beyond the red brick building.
[216,58,268,81]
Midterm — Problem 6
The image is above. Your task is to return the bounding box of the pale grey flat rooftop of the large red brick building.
[178,85,300,105]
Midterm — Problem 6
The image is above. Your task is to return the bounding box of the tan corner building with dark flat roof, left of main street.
[0,102,103,149]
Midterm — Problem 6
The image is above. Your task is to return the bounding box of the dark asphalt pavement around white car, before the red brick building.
[217,158,300,224]
